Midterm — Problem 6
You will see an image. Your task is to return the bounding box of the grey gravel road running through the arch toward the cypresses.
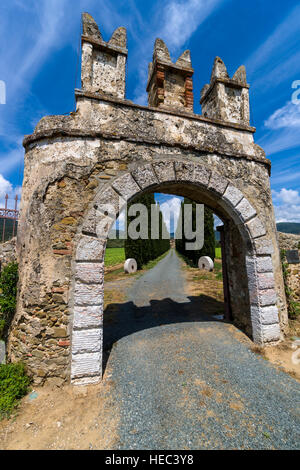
[104,250,300,450]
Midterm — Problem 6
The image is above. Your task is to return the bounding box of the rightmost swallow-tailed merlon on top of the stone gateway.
[200,57,250,125]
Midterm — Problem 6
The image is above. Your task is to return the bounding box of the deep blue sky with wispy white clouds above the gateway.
[0,0,300,228]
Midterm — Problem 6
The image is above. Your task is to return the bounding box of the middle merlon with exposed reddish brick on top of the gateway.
[147,39,194,111]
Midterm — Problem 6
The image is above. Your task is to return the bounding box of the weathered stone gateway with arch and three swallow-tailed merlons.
[8,14,288,384]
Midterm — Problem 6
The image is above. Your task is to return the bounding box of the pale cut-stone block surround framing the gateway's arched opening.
[71,162,281,384]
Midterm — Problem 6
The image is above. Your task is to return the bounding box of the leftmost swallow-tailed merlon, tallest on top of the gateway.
[81,13,127,98]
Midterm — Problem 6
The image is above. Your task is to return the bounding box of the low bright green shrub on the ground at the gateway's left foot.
[0,363,30,419]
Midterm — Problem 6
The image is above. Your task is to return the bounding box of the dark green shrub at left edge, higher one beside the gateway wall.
[0,263,18,338]
